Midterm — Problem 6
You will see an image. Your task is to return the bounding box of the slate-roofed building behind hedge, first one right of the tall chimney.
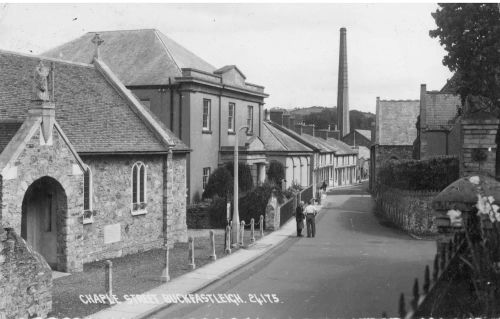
[370,97,420,191]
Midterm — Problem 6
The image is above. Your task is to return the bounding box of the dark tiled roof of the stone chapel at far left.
[0,51,188,153]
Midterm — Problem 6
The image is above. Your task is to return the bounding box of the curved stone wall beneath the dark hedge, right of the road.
[376,188,438,235]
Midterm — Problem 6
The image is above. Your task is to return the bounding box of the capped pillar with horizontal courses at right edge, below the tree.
[460,115,500,177]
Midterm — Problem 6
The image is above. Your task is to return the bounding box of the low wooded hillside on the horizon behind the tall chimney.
[290,106,375,130]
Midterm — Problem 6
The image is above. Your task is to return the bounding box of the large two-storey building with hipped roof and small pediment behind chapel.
[44,29,268,201]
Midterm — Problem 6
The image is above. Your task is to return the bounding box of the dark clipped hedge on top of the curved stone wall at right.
[379,156,459,191]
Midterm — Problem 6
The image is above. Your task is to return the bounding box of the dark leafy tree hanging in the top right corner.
[429,3,500,109]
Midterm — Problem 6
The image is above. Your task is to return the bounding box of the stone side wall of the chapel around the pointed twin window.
[78,155,187,262]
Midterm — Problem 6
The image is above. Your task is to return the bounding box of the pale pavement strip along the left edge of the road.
[86,201,321,319]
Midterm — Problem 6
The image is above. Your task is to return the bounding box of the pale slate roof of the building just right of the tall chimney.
[374,100,420,146]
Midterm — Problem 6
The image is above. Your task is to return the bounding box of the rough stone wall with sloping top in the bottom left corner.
[0,228,52,319]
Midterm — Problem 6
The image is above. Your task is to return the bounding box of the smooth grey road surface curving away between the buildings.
[152,186,436,318]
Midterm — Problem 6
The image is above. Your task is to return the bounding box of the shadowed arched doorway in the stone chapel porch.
[21,176,68,270]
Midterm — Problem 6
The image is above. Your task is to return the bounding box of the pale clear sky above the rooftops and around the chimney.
[0,3,451,113]
